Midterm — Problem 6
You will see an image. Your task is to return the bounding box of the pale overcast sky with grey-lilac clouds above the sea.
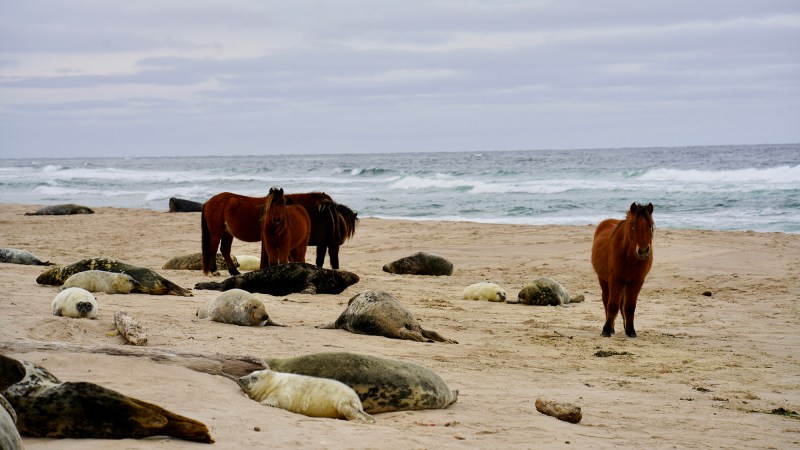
[0,0,800,157]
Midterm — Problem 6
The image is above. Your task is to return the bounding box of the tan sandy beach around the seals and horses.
[0,202,800,449]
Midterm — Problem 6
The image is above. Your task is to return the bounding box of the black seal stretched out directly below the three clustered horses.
[194,262,358,296]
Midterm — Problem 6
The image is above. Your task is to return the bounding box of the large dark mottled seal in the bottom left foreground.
[0,355,214,443]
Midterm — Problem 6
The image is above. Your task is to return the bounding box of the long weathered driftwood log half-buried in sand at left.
[0,341,267,380]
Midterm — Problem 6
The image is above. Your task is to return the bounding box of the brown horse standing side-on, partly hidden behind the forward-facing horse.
[200,192,333,275]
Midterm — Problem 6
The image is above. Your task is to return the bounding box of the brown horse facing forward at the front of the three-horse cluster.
[261,188,311,269]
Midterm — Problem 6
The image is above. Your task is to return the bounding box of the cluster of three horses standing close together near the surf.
[200,188,358,275]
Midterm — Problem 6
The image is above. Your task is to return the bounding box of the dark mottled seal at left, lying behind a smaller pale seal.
[36,258,192,297]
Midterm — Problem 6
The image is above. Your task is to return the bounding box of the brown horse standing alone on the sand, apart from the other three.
[592,203,655,337]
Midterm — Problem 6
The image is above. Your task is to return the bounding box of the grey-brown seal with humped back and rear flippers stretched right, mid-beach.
[317,291,458,344]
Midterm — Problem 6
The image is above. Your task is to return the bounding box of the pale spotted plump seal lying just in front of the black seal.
[197,289,286,327]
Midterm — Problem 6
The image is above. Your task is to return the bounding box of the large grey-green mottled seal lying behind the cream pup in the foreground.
[264,352,458,414]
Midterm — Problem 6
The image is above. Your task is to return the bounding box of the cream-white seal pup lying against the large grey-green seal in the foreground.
[238,369,375,423]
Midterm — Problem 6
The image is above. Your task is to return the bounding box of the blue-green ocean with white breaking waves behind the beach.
[0,144,800,233]
